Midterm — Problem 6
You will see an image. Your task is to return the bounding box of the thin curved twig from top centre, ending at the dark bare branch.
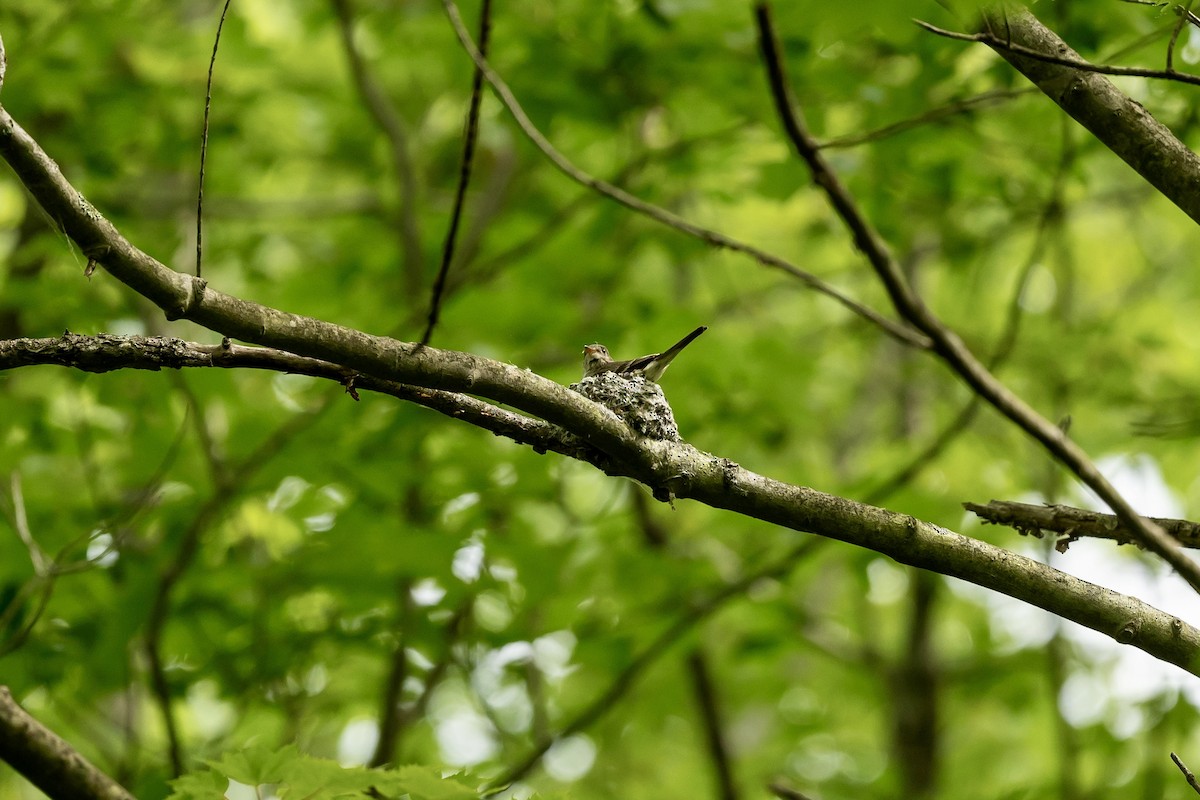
[443,0,929,349]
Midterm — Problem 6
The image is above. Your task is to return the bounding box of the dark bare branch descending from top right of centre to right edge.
[756,4,1200,591]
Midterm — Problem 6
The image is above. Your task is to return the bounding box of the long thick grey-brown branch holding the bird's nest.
[0,108,1200,674]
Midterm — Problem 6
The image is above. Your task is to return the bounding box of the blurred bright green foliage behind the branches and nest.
[0,0,1200,799]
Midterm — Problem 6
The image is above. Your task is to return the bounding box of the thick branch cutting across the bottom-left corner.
[0,686,134,800]
